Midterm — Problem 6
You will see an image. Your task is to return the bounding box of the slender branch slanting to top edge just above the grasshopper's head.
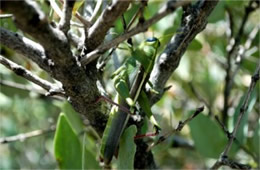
[81,1,190,65]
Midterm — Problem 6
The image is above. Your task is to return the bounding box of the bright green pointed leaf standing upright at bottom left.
[54,113,82,169]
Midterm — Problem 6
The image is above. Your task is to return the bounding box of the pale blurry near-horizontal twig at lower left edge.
[0,126,56,144]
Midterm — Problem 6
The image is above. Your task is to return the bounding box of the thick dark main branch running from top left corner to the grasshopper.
[0,0,107,135]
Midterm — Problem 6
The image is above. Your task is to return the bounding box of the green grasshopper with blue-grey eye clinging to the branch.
[101,37,160,165]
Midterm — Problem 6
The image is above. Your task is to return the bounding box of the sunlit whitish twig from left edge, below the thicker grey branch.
[0,55,63,95]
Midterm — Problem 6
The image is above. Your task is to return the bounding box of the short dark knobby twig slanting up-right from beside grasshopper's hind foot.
[147,106,204,152]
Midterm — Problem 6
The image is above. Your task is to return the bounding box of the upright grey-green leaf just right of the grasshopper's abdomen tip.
[118,125,137,169]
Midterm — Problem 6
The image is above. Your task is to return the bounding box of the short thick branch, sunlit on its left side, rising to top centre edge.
[85,0,131,52]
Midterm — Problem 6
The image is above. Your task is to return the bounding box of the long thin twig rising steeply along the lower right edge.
[211,61,260,169]
